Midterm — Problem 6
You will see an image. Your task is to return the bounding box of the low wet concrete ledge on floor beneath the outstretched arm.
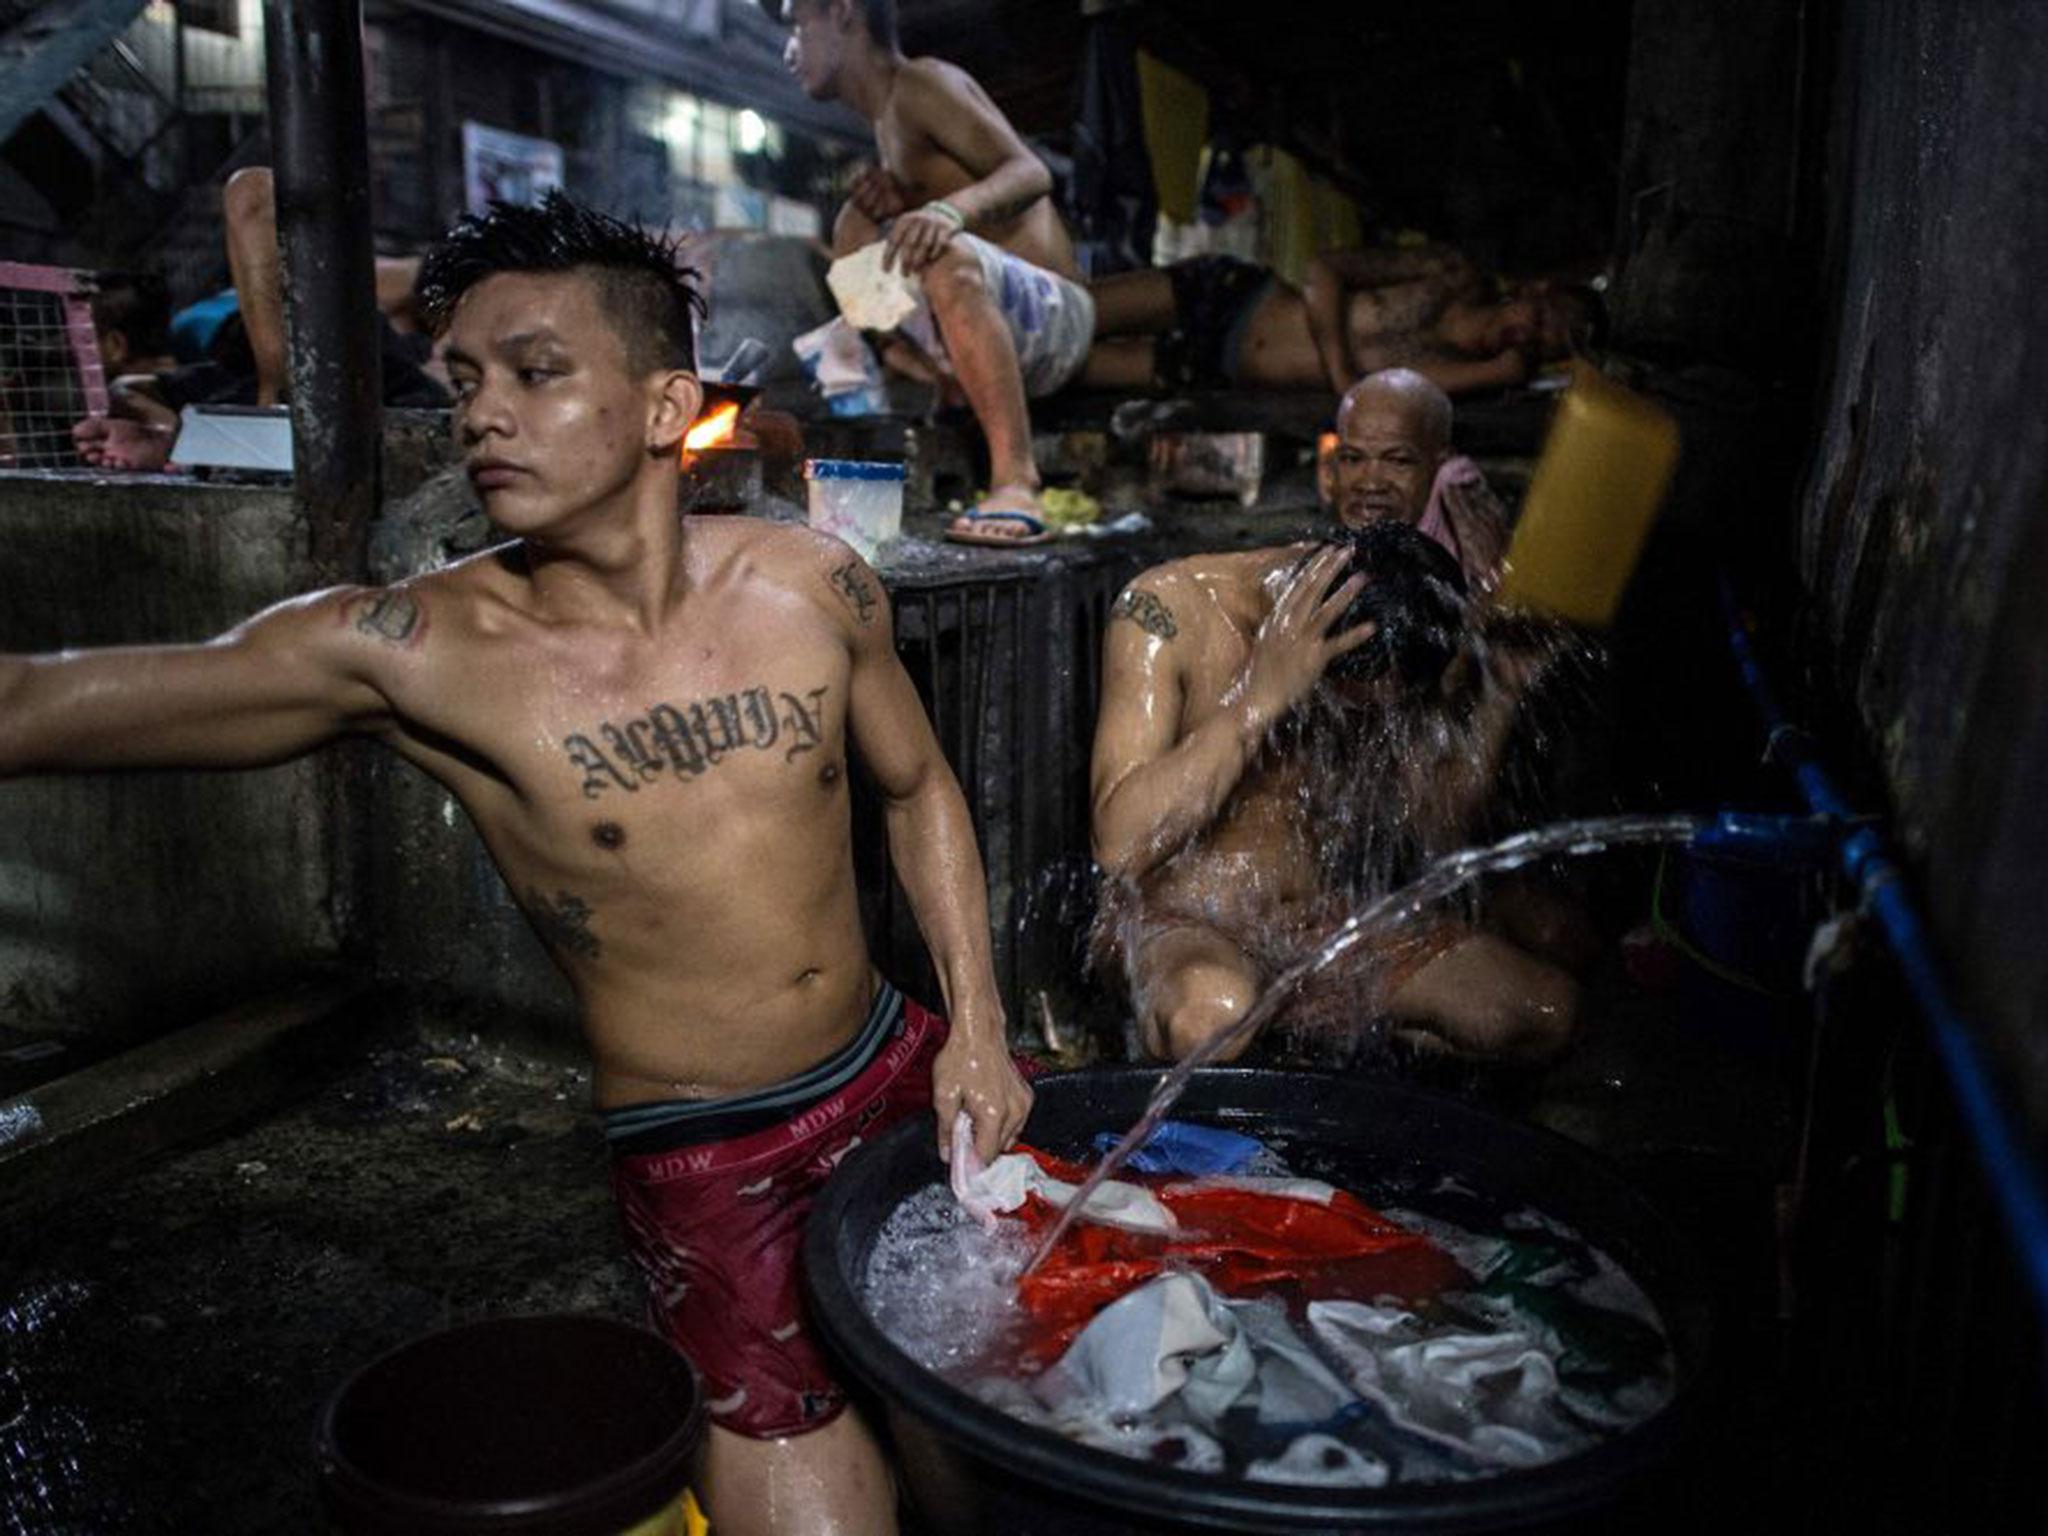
[0,975,377,1217]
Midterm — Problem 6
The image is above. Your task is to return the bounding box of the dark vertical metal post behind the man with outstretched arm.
[264,0,383,580]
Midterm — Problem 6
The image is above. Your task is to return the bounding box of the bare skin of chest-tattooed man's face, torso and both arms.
[0,272,1028,1151]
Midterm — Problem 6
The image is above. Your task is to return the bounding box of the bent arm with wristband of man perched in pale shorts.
[885,59,1053,272]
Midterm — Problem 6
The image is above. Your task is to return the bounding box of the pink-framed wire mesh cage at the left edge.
[0,262,106,469]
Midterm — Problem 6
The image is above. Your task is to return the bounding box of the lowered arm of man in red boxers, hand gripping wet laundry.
[825,549,1030,1159]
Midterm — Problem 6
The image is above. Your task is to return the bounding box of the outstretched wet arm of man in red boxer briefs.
[0,588,411,778]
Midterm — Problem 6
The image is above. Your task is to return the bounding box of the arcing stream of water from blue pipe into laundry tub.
[1024,813,1706,1274]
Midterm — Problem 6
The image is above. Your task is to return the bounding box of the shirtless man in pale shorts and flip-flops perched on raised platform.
[762,0,1096,543]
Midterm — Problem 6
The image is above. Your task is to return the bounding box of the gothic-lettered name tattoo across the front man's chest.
[561,688,829,801]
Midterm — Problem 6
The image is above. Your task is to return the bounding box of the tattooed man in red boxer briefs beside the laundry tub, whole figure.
[0,197,1030,1536]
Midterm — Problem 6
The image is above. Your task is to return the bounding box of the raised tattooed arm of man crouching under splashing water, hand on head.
[1090,547,1372,879]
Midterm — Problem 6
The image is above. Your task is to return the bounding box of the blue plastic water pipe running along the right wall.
[1702,571,2048,1325]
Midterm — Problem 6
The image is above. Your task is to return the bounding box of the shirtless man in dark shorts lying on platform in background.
[1081,248,1591,395]
